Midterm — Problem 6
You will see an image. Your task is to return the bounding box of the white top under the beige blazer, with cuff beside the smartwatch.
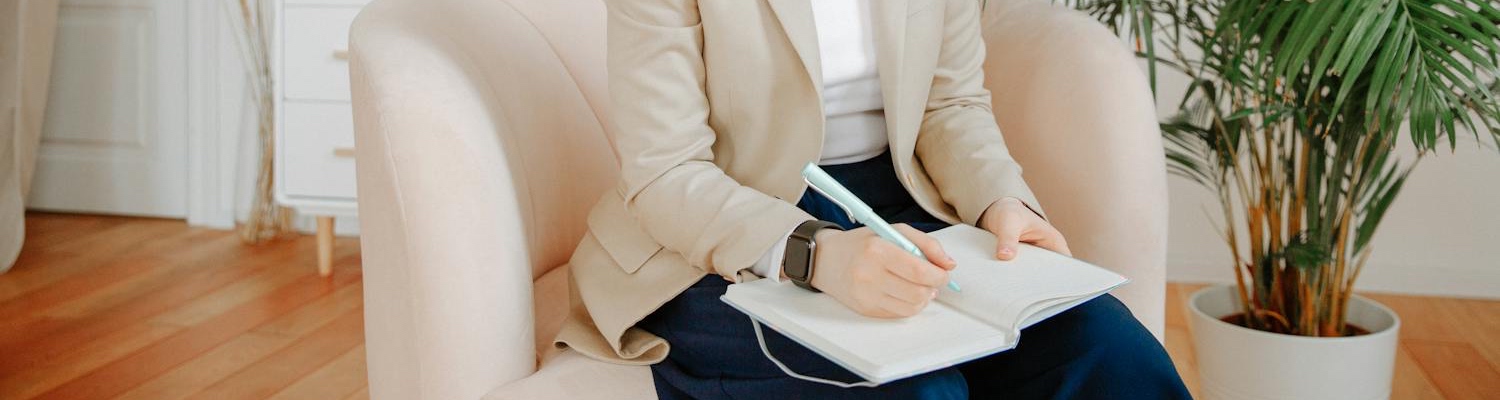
[750,0,890,280]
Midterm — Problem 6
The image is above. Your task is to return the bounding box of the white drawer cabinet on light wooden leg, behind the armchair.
[272,0,369,276]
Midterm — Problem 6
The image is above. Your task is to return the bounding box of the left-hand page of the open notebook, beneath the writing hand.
[723,279,1014,382]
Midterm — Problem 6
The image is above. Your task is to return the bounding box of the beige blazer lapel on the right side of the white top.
[870,0,917,161]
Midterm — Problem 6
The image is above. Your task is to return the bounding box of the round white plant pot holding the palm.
[1188,286,1401,400]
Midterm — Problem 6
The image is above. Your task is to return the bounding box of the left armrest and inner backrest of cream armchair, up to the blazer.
[350,0,618,400]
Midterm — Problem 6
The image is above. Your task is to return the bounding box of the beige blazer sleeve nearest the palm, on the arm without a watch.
[917,0,1046,225]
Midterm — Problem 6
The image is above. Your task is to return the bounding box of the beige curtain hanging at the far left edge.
[0,0,60,273]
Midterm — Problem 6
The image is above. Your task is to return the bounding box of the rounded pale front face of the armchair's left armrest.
[350,1,536,399]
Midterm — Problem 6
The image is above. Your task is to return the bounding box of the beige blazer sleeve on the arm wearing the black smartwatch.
[606,0,813,279]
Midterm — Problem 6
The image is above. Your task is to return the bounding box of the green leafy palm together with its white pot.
[1070,0,1500,399]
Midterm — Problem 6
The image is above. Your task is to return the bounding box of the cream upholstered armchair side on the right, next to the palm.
[983,0,1167,339]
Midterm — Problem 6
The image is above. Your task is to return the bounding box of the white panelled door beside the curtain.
[27,0,188,217]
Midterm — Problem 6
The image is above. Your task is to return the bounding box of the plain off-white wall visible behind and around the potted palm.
[1157,65,1500,298]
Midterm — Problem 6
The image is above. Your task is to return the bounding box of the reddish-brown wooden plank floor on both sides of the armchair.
[0,213,1500,400]
